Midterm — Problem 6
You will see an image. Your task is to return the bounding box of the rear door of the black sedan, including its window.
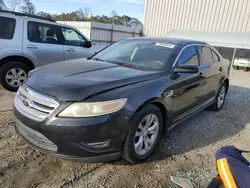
[198,46,223,101]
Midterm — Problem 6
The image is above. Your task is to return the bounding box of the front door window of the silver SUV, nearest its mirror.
[62,27,86,46]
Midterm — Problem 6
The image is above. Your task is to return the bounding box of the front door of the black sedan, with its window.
[172,45,204,122]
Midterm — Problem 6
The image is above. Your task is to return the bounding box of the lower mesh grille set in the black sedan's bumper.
[16,120,58,152]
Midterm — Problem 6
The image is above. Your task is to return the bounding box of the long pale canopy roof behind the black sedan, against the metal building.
[166,30,250,49]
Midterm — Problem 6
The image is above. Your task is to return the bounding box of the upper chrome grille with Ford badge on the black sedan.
[14,85,59,121]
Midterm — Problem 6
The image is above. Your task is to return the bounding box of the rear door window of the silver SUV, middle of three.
[28,22,64,44]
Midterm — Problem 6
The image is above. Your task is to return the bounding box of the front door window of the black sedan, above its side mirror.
[178,46,199,66]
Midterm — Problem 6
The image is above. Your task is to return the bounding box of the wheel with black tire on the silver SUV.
[0,61,29,92]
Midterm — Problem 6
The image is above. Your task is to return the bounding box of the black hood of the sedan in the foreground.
[26,59,160,101]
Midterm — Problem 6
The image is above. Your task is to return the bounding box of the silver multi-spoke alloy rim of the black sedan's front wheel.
[134,114,159,155]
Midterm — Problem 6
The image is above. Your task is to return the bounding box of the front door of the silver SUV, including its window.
[62,27,95,60]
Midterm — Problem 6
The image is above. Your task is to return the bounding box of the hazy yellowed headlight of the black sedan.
[59,99,127,117]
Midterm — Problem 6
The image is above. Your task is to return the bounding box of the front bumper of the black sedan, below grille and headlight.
[14,107,128,162]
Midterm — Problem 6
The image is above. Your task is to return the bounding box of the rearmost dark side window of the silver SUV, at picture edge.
[0,16,16,39]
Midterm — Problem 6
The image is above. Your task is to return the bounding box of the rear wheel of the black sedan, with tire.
[211,82,227,111]
